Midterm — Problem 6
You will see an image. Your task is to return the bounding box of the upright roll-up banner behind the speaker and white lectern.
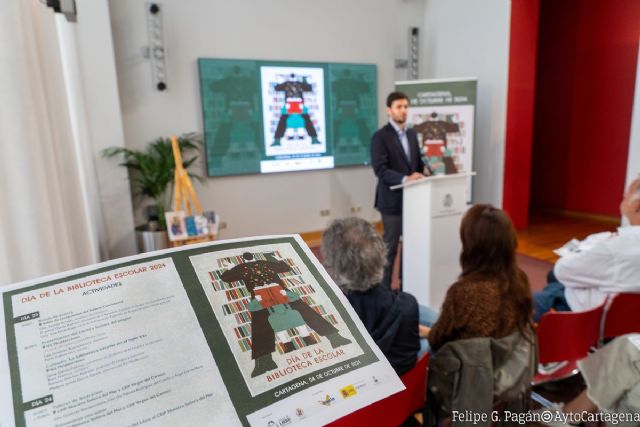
[395,78,478,202]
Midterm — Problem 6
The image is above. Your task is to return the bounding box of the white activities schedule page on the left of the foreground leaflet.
[2,258,238,427]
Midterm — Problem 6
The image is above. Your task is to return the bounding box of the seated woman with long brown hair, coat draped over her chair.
[424,205,535,426]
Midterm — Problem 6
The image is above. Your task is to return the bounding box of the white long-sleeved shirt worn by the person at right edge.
[553,225,640,311]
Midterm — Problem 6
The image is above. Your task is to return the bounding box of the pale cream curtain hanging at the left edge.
[0,0,101,285]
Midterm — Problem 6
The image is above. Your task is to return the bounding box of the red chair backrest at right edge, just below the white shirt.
[602,293,640,338]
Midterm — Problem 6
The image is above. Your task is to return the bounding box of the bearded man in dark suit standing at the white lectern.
[371,92,425,287]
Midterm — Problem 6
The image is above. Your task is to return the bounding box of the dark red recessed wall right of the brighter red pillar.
[531,0,640,216]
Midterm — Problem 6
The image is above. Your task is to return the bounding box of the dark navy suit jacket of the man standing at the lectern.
[371,123,424,215]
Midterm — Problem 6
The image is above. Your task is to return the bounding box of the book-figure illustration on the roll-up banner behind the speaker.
[413,112,460,174]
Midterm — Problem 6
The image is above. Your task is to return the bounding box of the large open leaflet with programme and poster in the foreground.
[0,236,403,427]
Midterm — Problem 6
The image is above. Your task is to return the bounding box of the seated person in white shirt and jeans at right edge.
[533,178,640,321]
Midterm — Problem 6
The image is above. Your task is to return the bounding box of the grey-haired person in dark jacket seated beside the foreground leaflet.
[322,218,437,375]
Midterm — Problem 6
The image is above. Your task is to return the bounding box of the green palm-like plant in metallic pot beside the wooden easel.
[102,133,202,252]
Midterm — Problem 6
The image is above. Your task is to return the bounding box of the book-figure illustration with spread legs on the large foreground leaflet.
[221,252,351,378]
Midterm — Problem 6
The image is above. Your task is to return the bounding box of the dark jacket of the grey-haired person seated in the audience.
[347,285,420,375]
